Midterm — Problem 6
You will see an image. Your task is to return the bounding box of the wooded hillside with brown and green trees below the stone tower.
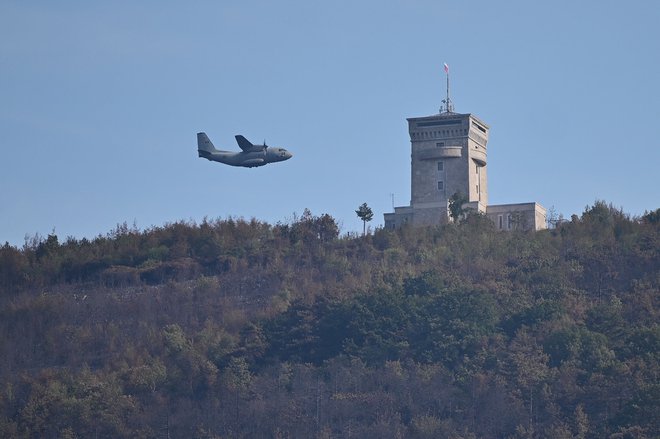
[0,202,660,439]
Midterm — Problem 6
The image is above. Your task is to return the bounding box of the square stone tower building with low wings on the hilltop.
[384,87,546,230]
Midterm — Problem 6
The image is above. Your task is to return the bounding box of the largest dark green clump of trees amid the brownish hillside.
[264,275,498,365]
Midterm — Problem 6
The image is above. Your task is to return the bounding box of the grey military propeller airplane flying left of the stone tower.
[197,133,293,168]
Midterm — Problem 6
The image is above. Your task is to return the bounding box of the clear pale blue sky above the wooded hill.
[0,0,660,246]
